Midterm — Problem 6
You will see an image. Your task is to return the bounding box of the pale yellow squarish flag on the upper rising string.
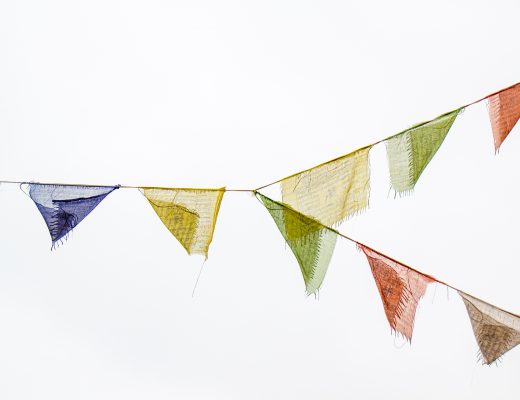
[281,147,370,226]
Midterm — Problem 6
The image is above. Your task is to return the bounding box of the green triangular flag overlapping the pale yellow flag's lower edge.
[256,192,337,295]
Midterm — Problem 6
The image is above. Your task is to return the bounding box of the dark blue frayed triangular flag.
[29,183,118,248]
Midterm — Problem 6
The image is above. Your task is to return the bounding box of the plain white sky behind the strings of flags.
[0,0,520,400]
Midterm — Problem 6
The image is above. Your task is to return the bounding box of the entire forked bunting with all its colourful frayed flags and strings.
[0,83,520,364]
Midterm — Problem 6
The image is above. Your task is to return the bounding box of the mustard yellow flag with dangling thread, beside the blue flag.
[140,188,225,258]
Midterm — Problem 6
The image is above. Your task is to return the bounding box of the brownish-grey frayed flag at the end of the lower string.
[458,291,520,365]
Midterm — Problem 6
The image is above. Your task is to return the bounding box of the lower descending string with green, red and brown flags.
[255,192,520,365]
